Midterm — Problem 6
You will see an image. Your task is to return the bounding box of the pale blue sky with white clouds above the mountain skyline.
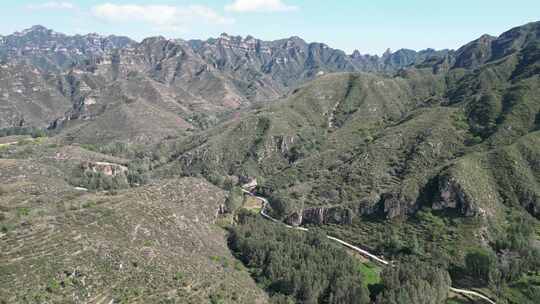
[0,0,540,54]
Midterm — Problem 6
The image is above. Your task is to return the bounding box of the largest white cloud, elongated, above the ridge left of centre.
[92,3,234,32]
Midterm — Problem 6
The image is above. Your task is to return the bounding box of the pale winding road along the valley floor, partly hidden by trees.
[242,189,497,304]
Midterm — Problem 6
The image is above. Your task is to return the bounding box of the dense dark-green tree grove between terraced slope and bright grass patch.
[229,214,369,304]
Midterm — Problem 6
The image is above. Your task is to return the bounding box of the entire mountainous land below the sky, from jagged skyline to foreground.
[0,20,540,304]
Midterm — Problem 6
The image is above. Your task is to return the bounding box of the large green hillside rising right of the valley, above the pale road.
[149,23,540,303]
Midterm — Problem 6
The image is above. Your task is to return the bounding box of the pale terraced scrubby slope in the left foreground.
[0,154,266,303]
